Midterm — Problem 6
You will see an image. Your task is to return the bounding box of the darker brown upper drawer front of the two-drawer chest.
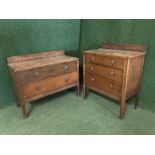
[21,61,77,84]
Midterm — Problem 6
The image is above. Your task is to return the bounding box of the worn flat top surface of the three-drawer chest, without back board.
[84,48,145,58]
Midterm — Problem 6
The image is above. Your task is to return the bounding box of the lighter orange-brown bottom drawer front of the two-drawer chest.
[22,72,78,98]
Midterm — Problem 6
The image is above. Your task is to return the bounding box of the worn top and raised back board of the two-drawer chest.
[8,52,78,71]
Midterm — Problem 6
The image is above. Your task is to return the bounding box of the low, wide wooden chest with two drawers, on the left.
[7,51,79,117]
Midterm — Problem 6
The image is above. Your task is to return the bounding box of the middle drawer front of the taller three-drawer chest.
[85,63,123,81]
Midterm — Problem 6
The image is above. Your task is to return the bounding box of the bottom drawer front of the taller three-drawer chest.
[85,73,122,97]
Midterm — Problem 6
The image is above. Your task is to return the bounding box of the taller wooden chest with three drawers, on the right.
[83,43,146,118]
